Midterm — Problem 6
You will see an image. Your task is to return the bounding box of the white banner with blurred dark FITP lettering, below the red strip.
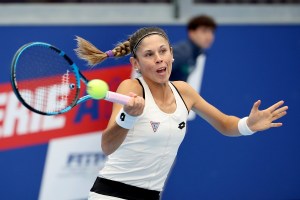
[39,132,106,200]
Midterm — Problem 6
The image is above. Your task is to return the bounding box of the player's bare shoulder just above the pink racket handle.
[117,79,143,96]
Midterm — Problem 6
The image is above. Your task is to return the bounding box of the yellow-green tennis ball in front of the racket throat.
[87,79,108,99]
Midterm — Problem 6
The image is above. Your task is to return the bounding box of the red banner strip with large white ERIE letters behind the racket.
[0,65,131,150]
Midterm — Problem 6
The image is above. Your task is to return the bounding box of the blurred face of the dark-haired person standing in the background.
[189,26,215,49]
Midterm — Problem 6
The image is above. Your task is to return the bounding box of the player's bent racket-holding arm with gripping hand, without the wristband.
[101,79,145,155]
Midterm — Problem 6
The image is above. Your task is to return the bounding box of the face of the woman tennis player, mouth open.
[132,35,173,83]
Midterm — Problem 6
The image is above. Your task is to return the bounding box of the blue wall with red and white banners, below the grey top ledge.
[0,25,300,200]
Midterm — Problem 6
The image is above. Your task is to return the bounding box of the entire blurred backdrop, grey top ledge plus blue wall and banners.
[0,0,300,200]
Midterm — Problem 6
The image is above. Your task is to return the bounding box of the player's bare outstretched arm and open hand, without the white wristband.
[174,81,288,136]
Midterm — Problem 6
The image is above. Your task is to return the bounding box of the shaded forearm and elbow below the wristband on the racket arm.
[101,123,128,155]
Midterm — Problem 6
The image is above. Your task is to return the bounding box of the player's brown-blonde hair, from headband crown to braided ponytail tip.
[75,27,170,67]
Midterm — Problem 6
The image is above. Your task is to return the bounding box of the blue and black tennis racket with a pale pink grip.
[11,42,130,115]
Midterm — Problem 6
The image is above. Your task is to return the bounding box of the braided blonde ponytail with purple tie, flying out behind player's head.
[75,36,131,67]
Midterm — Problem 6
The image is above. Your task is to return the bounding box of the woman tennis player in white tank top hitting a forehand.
[76,27,288,200]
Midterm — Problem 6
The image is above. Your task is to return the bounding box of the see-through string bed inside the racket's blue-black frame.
[16,46,78,113]
